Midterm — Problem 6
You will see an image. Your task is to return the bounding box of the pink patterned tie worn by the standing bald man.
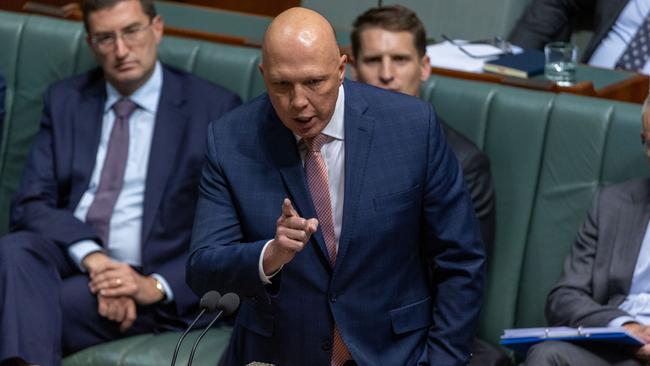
[305,134,350,366]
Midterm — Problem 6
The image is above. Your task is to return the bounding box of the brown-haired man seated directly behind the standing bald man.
[352,5,510,365]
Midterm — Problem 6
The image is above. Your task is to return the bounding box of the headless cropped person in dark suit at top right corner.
[509,0,650,74]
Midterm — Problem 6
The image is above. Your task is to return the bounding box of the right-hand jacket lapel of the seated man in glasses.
[142,67,188,243]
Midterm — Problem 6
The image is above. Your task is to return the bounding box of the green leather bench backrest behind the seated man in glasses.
[0,11,264,234]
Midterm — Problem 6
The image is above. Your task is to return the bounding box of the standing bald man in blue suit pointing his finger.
[187,8,484,365]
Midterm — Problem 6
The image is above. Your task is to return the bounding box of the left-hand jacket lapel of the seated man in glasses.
[70,71,106,208]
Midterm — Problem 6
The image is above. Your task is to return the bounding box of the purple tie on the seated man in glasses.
[86,98,137,245]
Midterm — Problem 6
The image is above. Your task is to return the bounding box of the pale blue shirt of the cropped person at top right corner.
[589,0,650,74]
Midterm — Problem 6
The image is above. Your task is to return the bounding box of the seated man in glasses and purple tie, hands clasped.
[0,0,241,366]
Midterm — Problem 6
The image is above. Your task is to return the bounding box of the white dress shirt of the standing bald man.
[259,85,345,284]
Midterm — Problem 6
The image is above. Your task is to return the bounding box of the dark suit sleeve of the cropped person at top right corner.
[508,0,593,50]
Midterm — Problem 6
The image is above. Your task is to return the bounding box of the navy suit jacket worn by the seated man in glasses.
[11,63,241,319]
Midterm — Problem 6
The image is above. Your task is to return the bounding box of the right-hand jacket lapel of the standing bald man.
[335,82,375,274]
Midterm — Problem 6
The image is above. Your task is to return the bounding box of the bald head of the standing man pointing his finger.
[260,8,346,138]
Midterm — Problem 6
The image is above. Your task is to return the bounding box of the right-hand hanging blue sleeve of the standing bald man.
[419,107,485,365]
